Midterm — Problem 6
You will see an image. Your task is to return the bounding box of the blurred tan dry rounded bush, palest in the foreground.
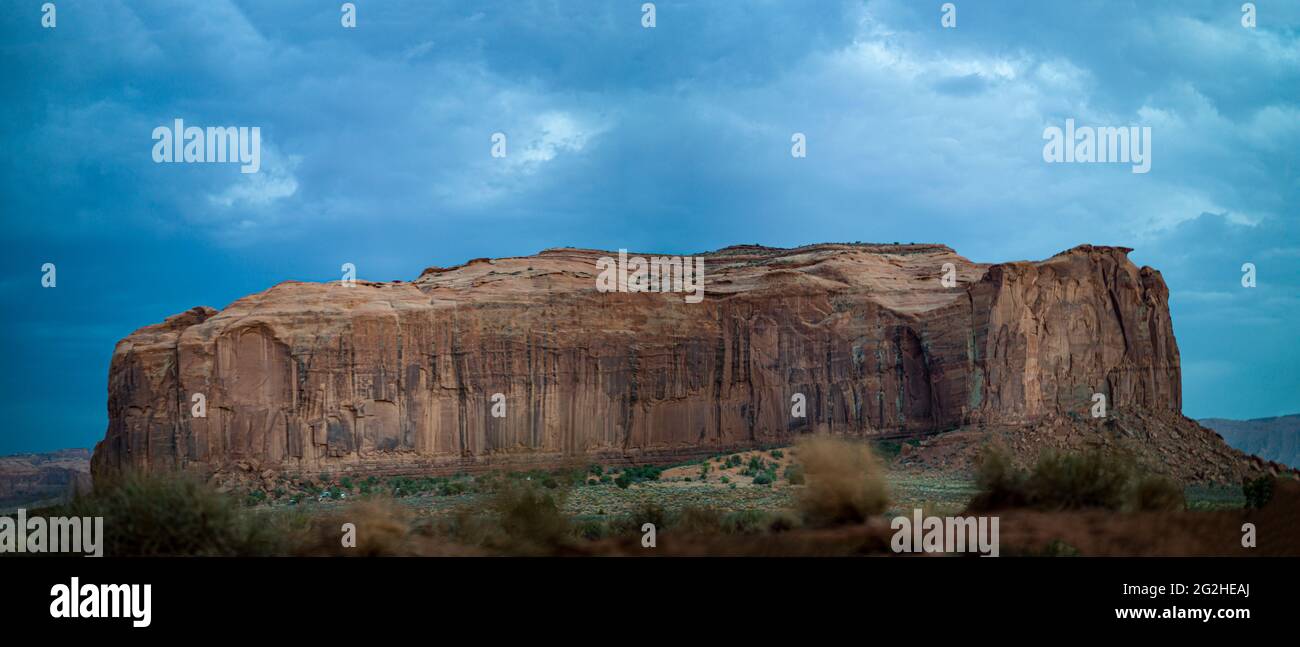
[798,437,889,525]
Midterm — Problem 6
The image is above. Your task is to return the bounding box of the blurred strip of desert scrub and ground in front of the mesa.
[25,437,1290,556]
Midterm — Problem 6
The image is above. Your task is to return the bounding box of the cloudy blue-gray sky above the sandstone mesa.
[0,0,1300,453]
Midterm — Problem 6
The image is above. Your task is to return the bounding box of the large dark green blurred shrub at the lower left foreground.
[59,473,294,556]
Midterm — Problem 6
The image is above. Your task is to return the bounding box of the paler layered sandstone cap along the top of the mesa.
[127,243,1138,348]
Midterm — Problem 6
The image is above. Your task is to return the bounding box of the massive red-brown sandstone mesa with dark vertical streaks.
[92,244,1182,474]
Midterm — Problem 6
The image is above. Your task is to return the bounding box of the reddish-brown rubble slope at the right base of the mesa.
[893,412,1296,483]
